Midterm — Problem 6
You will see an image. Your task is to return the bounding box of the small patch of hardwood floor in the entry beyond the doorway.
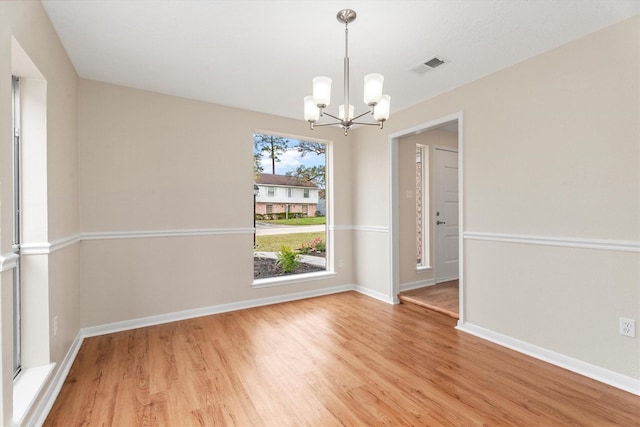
[398,280,460,319]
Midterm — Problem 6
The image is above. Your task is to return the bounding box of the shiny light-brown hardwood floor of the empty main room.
[44,292,640,427]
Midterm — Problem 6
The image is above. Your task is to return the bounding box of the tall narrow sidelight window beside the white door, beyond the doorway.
[416,144,430,268]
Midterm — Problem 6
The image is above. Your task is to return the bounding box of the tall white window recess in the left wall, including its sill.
[9,43,53,420]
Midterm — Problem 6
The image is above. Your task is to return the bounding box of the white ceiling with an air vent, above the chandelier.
[43,0,640,119]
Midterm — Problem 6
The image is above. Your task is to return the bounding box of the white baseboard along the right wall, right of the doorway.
[456,323,640,396]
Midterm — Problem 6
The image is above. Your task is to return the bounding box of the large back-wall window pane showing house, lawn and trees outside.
[253,134,327,279]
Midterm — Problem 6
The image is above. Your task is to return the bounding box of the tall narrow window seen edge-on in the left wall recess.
[11,77,22,378]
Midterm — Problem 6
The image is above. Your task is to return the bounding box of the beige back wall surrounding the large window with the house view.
[79,80,353,326]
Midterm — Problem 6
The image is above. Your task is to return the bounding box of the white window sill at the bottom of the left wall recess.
[13,363,56,426]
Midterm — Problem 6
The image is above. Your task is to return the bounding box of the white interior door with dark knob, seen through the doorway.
[433,148,459,283]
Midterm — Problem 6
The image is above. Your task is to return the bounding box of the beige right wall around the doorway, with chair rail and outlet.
[354,17,640,380]
